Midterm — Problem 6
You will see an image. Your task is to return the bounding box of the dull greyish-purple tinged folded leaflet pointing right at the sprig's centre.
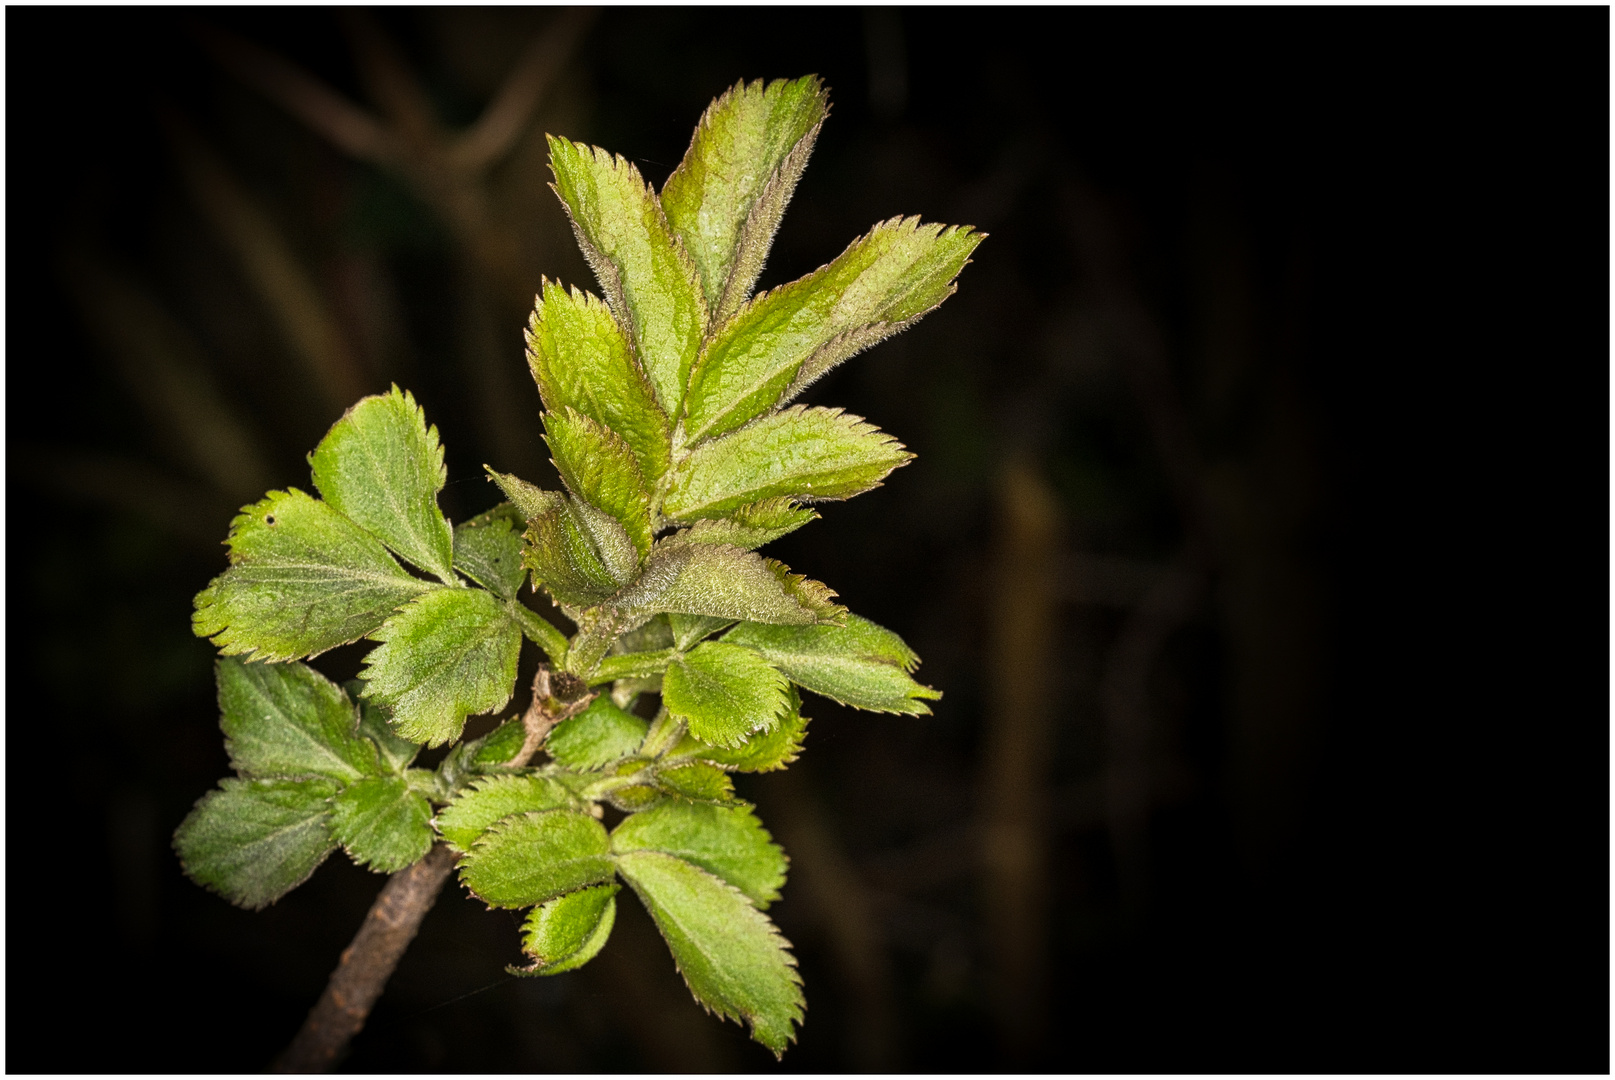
[612,539,845,626]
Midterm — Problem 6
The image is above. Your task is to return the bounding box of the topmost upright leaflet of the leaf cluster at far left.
[308,386,459,584]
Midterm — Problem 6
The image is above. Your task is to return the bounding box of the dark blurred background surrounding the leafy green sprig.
[5,8,1609,1072]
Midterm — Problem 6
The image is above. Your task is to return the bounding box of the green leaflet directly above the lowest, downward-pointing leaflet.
[610,802,785,907]
